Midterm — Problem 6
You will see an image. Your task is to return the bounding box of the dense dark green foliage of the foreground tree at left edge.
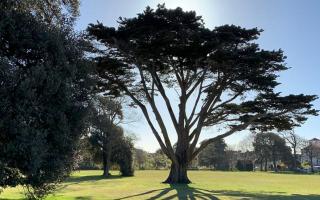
[0,1,88,198]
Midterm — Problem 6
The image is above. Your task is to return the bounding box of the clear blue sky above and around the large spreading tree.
[76,0,320,151]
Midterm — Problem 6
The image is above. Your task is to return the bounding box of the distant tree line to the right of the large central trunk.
[198,131,320,172]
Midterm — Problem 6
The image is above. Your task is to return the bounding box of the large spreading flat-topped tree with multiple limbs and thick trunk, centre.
[87,5,316,182]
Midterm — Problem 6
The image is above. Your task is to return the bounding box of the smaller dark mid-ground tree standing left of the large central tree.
[87,95,133,176]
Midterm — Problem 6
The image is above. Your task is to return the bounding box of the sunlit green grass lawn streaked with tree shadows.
[0,170,320,200]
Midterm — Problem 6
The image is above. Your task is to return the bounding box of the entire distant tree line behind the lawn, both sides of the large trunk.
[79,131,320,172]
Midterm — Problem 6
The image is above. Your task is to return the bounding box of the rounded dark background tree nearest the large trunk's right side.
[198,139,229,170]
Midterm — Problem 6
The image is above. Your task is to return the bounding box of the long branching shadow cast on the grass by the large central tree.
[118,184,320,200]
